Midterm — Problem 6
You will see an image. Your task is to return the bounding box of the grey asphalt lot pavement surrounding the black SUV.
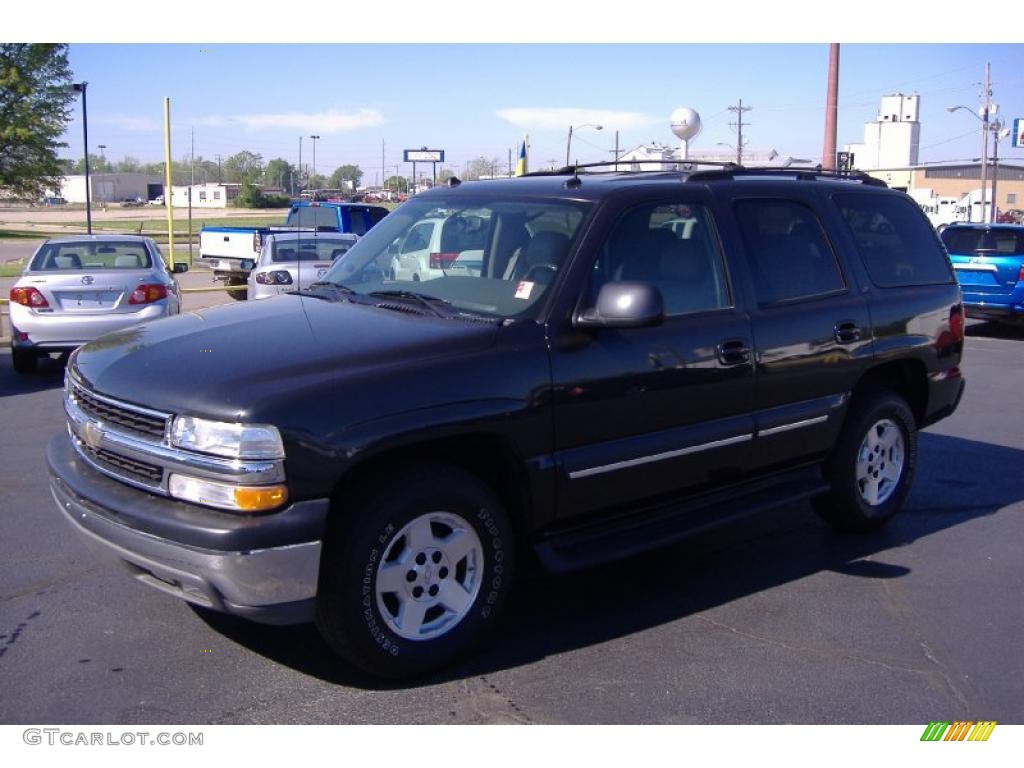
[0,317,1024,724]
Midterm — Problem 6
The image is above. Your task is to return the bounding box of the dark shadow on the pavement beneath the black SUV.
[188,433,1024,690]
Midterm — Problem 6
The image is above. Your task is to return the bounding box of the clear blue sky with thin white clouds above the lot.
[44,38,1024,183]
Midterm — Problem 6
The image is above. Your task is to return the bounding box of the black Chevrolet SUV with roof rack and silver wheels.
[48,167,964,677]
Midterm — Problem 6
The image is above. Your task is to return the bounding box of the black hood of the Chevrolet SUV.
[74,295,498,421]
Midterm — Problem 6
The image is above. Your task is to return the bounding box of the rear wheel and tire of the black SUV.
[813,390,918,532]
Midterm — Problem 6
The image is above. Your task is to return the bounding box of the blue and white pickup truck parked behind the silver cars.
[199,201,388,299]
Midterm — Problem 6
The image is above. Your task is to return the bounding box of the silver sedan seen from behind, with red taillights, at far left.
[10,234,188,374]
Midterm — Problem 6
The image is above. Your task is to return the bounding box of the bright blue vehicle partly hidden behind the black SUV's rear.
[939,223,1024,322]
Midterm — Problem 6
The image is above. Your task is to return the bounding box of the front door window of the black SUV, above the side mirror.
[590,203,731,315]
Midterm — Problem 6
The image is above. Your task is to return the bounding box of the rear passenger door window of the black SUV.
[735,198,846,305]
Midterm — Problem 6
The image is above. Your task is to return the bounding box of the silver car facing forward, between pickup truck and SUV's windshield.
[249,231,359,299]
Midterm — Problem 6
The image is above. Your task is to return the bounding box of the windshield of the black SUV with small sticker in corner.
[324,195,591,317]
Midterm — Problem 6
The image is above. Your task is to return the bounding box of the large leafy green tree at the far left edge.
[0,43,75,199]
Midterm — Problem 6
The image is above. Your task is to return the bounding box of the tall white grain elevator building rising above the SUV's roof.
[845,93,921,171]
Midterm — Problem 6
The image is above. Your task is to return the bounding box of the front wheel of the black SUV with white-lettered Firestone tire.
[316,465,515,679]
